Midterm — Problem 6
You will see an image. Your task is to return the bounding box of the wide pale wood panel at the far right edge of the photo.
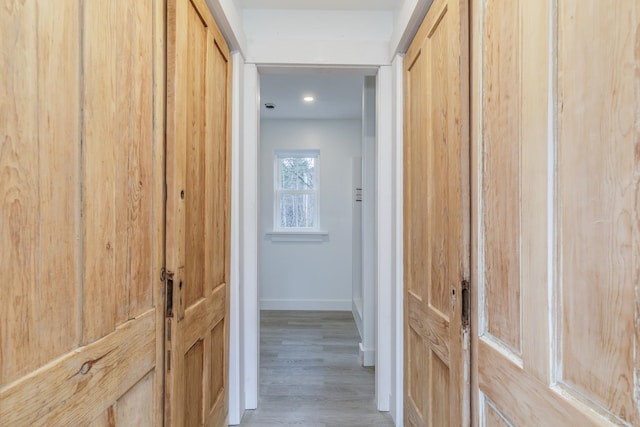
[557,1,640,424]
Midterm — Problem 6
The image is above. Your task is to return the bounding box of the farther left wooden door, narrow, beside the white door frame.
[165,0,231,427]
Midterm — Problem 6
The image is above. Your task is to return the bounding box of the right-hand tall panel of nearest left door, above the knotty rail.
[82,1,153,343]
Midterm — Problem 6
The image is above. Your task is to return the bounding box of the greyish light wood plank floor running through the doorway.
[240,311,394,427]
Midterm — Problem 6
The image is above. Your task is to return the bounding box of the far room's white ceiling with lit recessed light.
[260,73,364,119]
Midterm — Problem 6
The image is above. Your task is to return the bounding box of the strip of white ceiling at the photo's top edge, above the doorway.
[238,0,402,10]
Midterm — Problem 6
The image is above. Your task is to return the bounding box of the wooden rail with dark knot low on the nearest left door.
[0,310,156,426]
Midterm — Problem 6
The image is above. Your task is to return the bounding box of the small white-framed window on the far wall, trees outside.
[274,150,320,231]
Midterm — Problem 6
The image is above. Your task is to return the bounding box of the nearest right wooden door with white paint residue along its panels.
[472,0,640,427]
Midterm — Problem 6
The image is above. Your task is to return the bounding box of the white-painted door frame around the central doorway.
[230,58,403,422]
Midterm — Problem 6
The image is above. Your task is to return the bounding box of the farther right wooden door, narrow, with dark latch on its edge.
[404,0,470,426]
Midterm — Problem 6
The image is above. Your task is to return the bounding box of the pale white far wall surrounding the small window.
[259,120,361,310]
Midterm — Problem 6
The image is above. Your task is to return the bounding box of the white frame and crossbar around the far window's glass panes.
[273,150,321,233]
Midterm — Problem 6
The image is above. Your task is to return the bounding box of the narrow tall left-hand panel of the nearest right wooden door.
[481,0,522,355]
